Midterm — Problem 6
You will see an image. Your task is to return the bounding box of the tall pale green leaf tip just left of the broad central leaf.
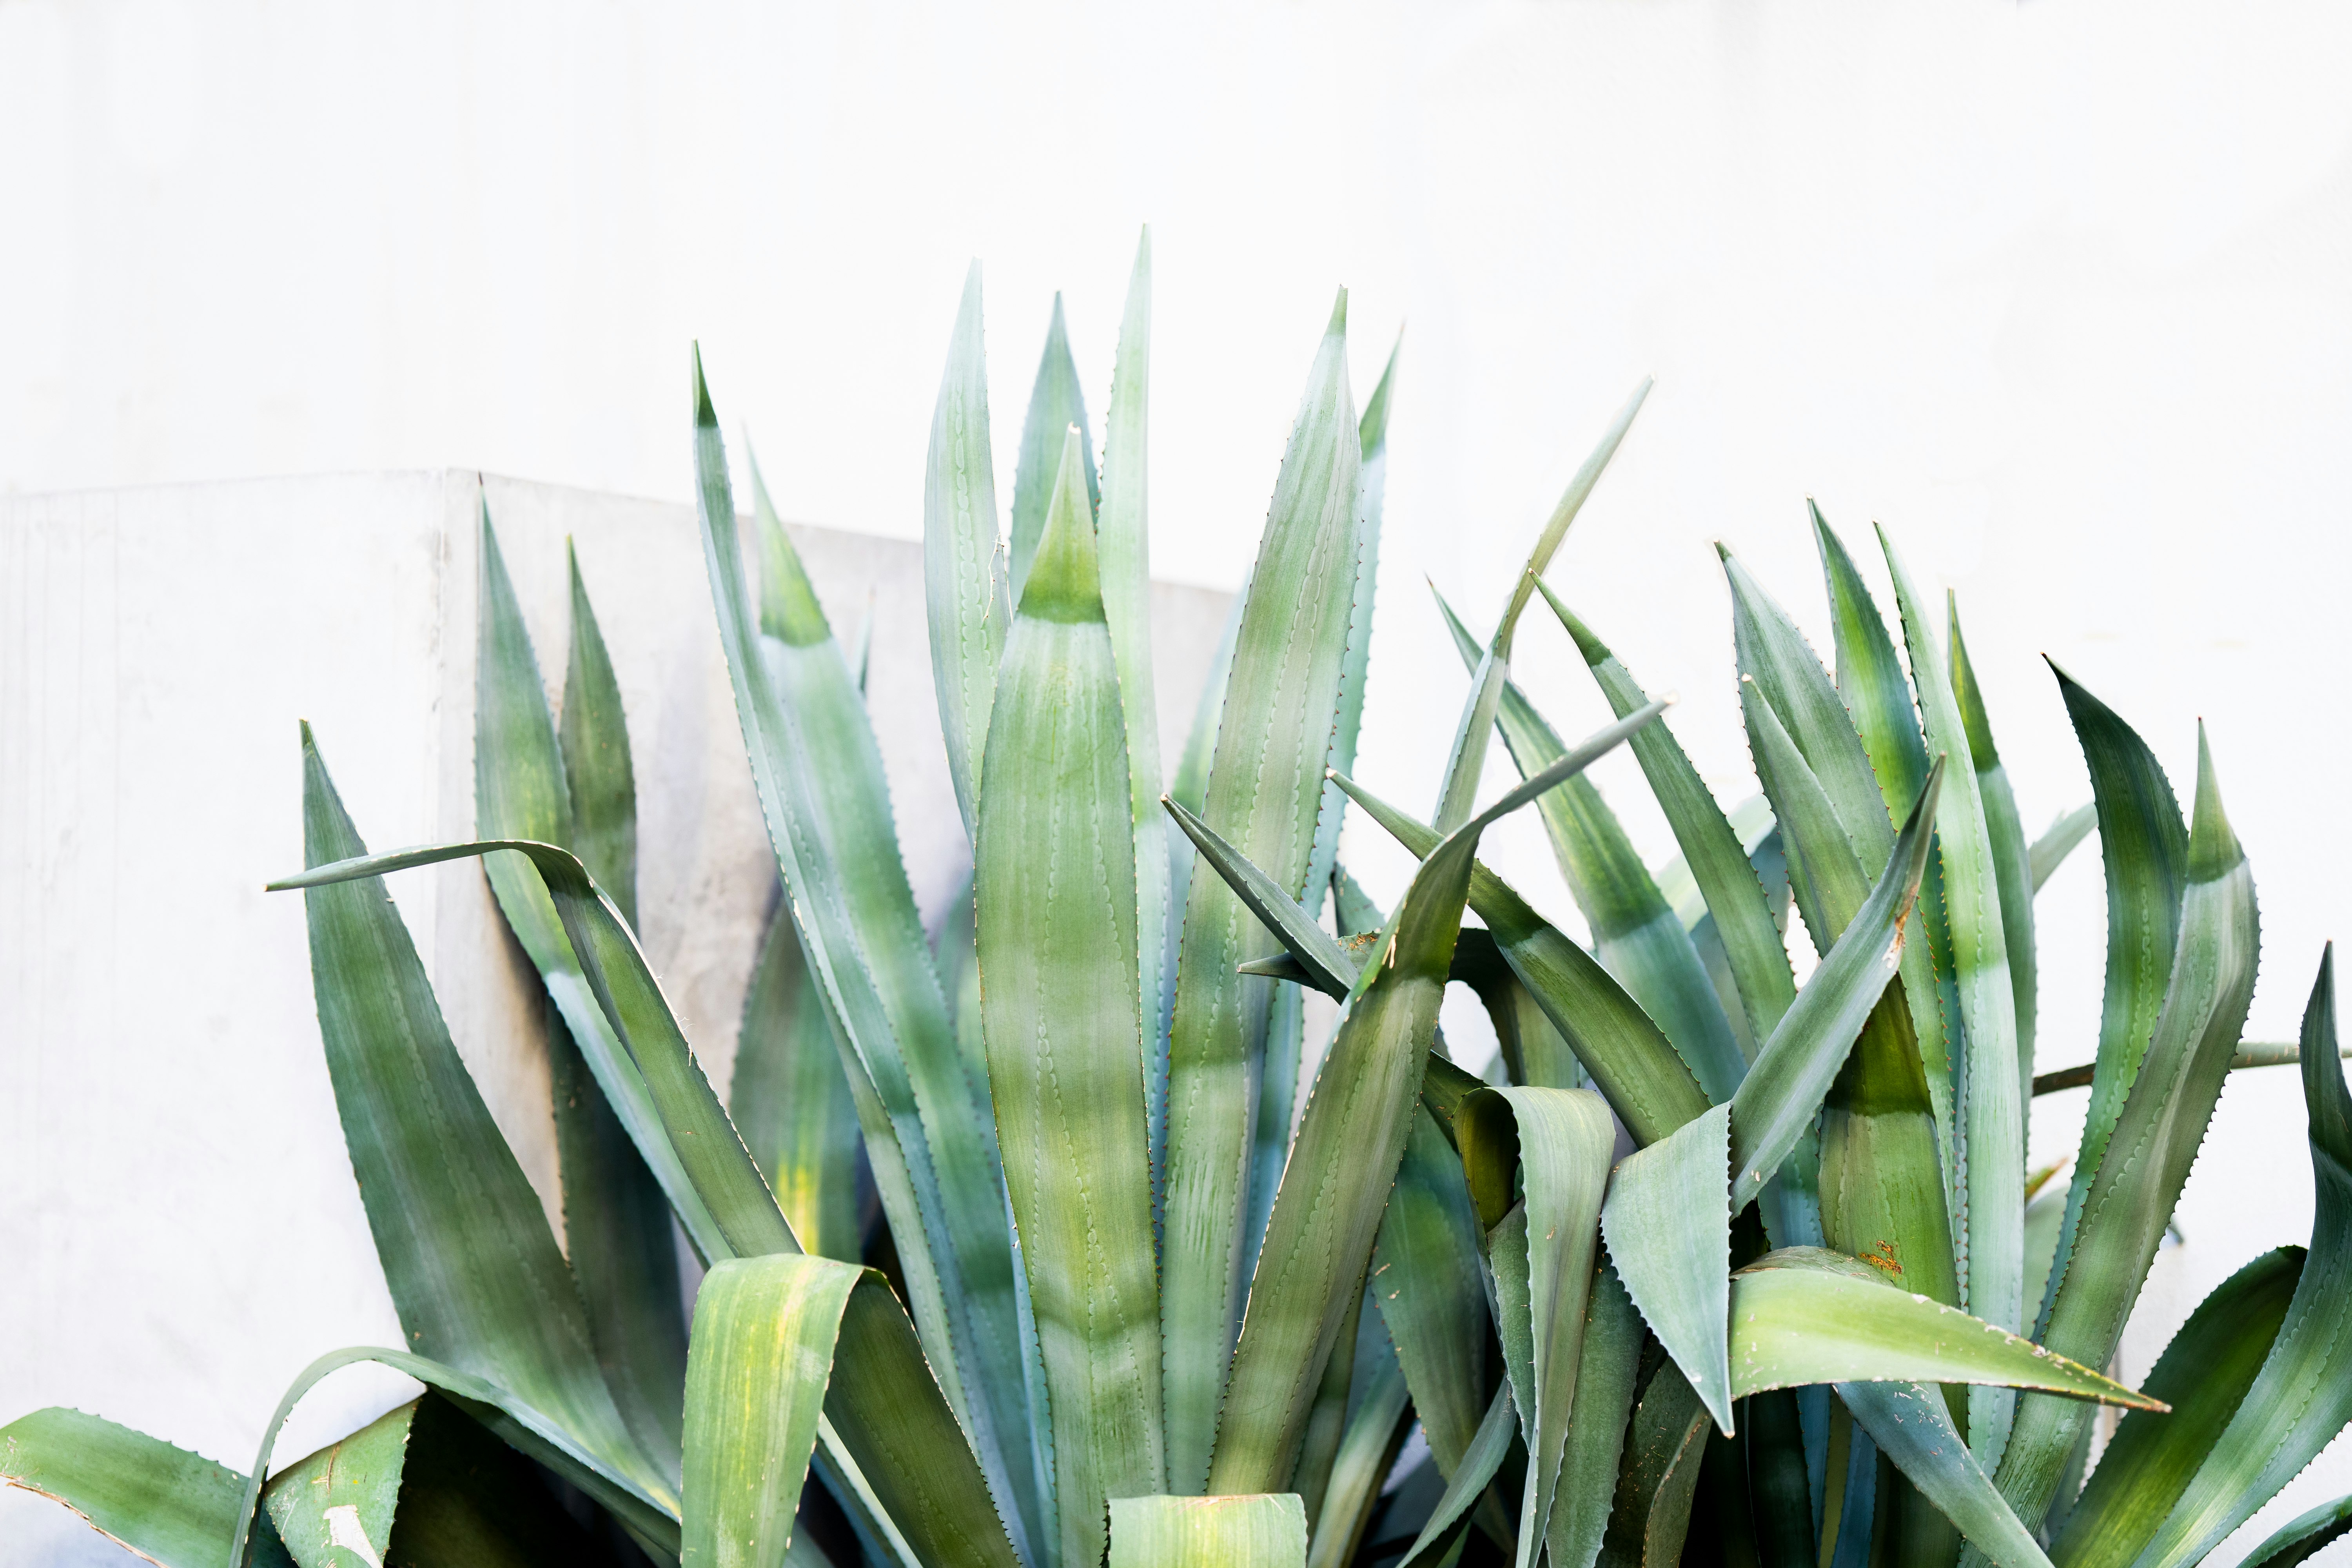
[922,261,1011,835]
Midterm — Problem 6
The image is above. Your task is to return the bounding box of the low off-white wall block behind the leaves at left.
[0,470,1225,1568]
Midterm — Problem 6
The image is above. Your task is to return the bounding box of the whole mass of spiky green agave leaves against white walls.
[0,232,2352,1568]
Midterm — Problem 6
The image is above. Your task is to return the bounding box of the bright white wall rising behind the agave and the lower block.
[0,0,2352,1552]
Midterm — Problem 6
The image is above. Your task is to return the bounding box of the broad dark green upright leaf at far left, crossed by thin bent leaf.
[303,733,675,1504]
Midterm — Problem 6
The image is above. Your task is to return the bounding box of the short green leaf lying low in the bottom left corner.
[0,1406,292,1568]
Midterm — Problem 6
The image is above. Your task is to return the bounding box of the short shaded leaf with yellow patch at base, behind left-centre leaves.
[727,905,863,1262]
